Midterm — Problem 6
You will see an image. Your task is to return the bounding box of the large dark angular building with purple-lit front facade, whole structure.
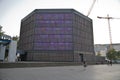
[19,9,95,62]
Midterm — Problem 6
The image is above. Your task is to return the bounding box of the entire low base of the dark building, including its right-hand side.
[21,50,94,62]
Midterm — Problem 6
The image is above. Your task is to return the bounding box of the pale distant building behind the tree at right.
[94,43,120,57]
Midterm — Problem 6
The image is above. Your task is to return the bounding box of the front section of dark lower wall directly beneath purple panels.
[26,51,74,62]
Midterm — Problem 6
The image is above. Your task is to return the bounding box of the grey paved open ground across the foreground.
[0,64,120,80]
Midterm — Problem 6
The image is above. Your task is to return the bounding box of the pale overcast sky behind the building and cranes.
[0,0,120,44]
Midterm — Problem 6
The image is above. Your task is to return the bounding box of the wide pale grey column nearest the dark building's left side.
[8,41,17,62]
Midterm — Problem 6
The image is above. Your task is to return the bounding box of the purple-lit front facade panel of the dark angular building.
[34,13,73,50]
